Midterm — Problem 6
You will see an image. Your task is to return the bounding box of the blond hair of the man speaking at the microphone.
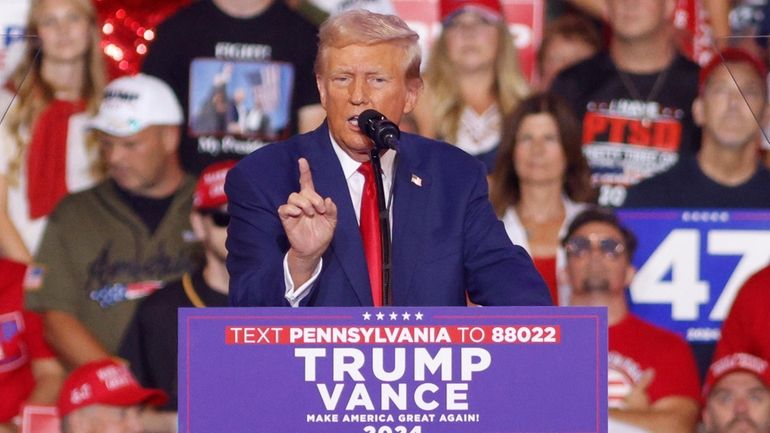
[315,9,422,79]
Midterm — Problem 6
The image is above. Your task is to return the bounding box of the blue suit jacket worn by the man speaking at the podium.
[225,124,551,306]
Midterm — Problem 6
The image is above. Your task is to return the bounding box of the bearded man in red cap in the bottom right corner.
[703,353,770,433]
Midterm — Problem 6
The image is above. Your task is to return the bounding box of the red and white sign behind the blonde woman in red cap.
[392,0,545,79]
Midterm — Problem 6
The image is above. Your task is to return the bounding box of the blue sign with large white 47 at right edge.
[618,209,770,342]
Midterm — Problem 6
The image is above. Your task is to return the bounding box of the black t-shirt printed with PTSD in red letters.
[551,52,700,206]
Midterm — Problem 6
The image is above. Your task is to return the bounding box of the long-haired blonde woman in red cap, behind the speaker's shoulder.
[414,0,529,170]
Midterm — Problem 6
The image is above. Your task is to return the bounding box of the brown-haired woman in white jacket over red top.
[489,93,596,305]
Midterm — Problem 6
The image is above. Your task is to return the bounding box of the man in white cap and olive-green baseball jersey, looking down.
[27,74,195,367]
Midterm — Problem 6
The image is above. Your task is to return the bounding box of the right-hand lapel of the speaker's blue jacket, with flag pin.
[391,140,432,305]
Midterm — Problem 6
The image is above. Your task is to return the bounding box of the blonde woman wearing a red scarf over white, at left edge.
[0,0,106,262]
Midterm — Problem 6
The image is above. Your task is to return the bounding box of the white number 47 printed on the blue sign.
[631,229,770,321]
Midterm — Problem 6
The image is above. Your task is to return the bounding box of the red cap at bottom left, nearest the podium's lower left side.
[57,358,168,417]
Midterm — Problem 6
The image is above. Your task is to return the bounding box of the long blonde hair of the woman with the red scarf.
[7,0,106,184]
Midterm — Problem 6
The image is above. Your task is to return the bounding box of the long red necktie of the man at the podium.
[358,161,382,307]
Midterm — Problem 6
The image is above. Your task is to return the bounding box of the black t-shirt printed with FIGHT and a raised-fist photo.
[142,0,319,174]
